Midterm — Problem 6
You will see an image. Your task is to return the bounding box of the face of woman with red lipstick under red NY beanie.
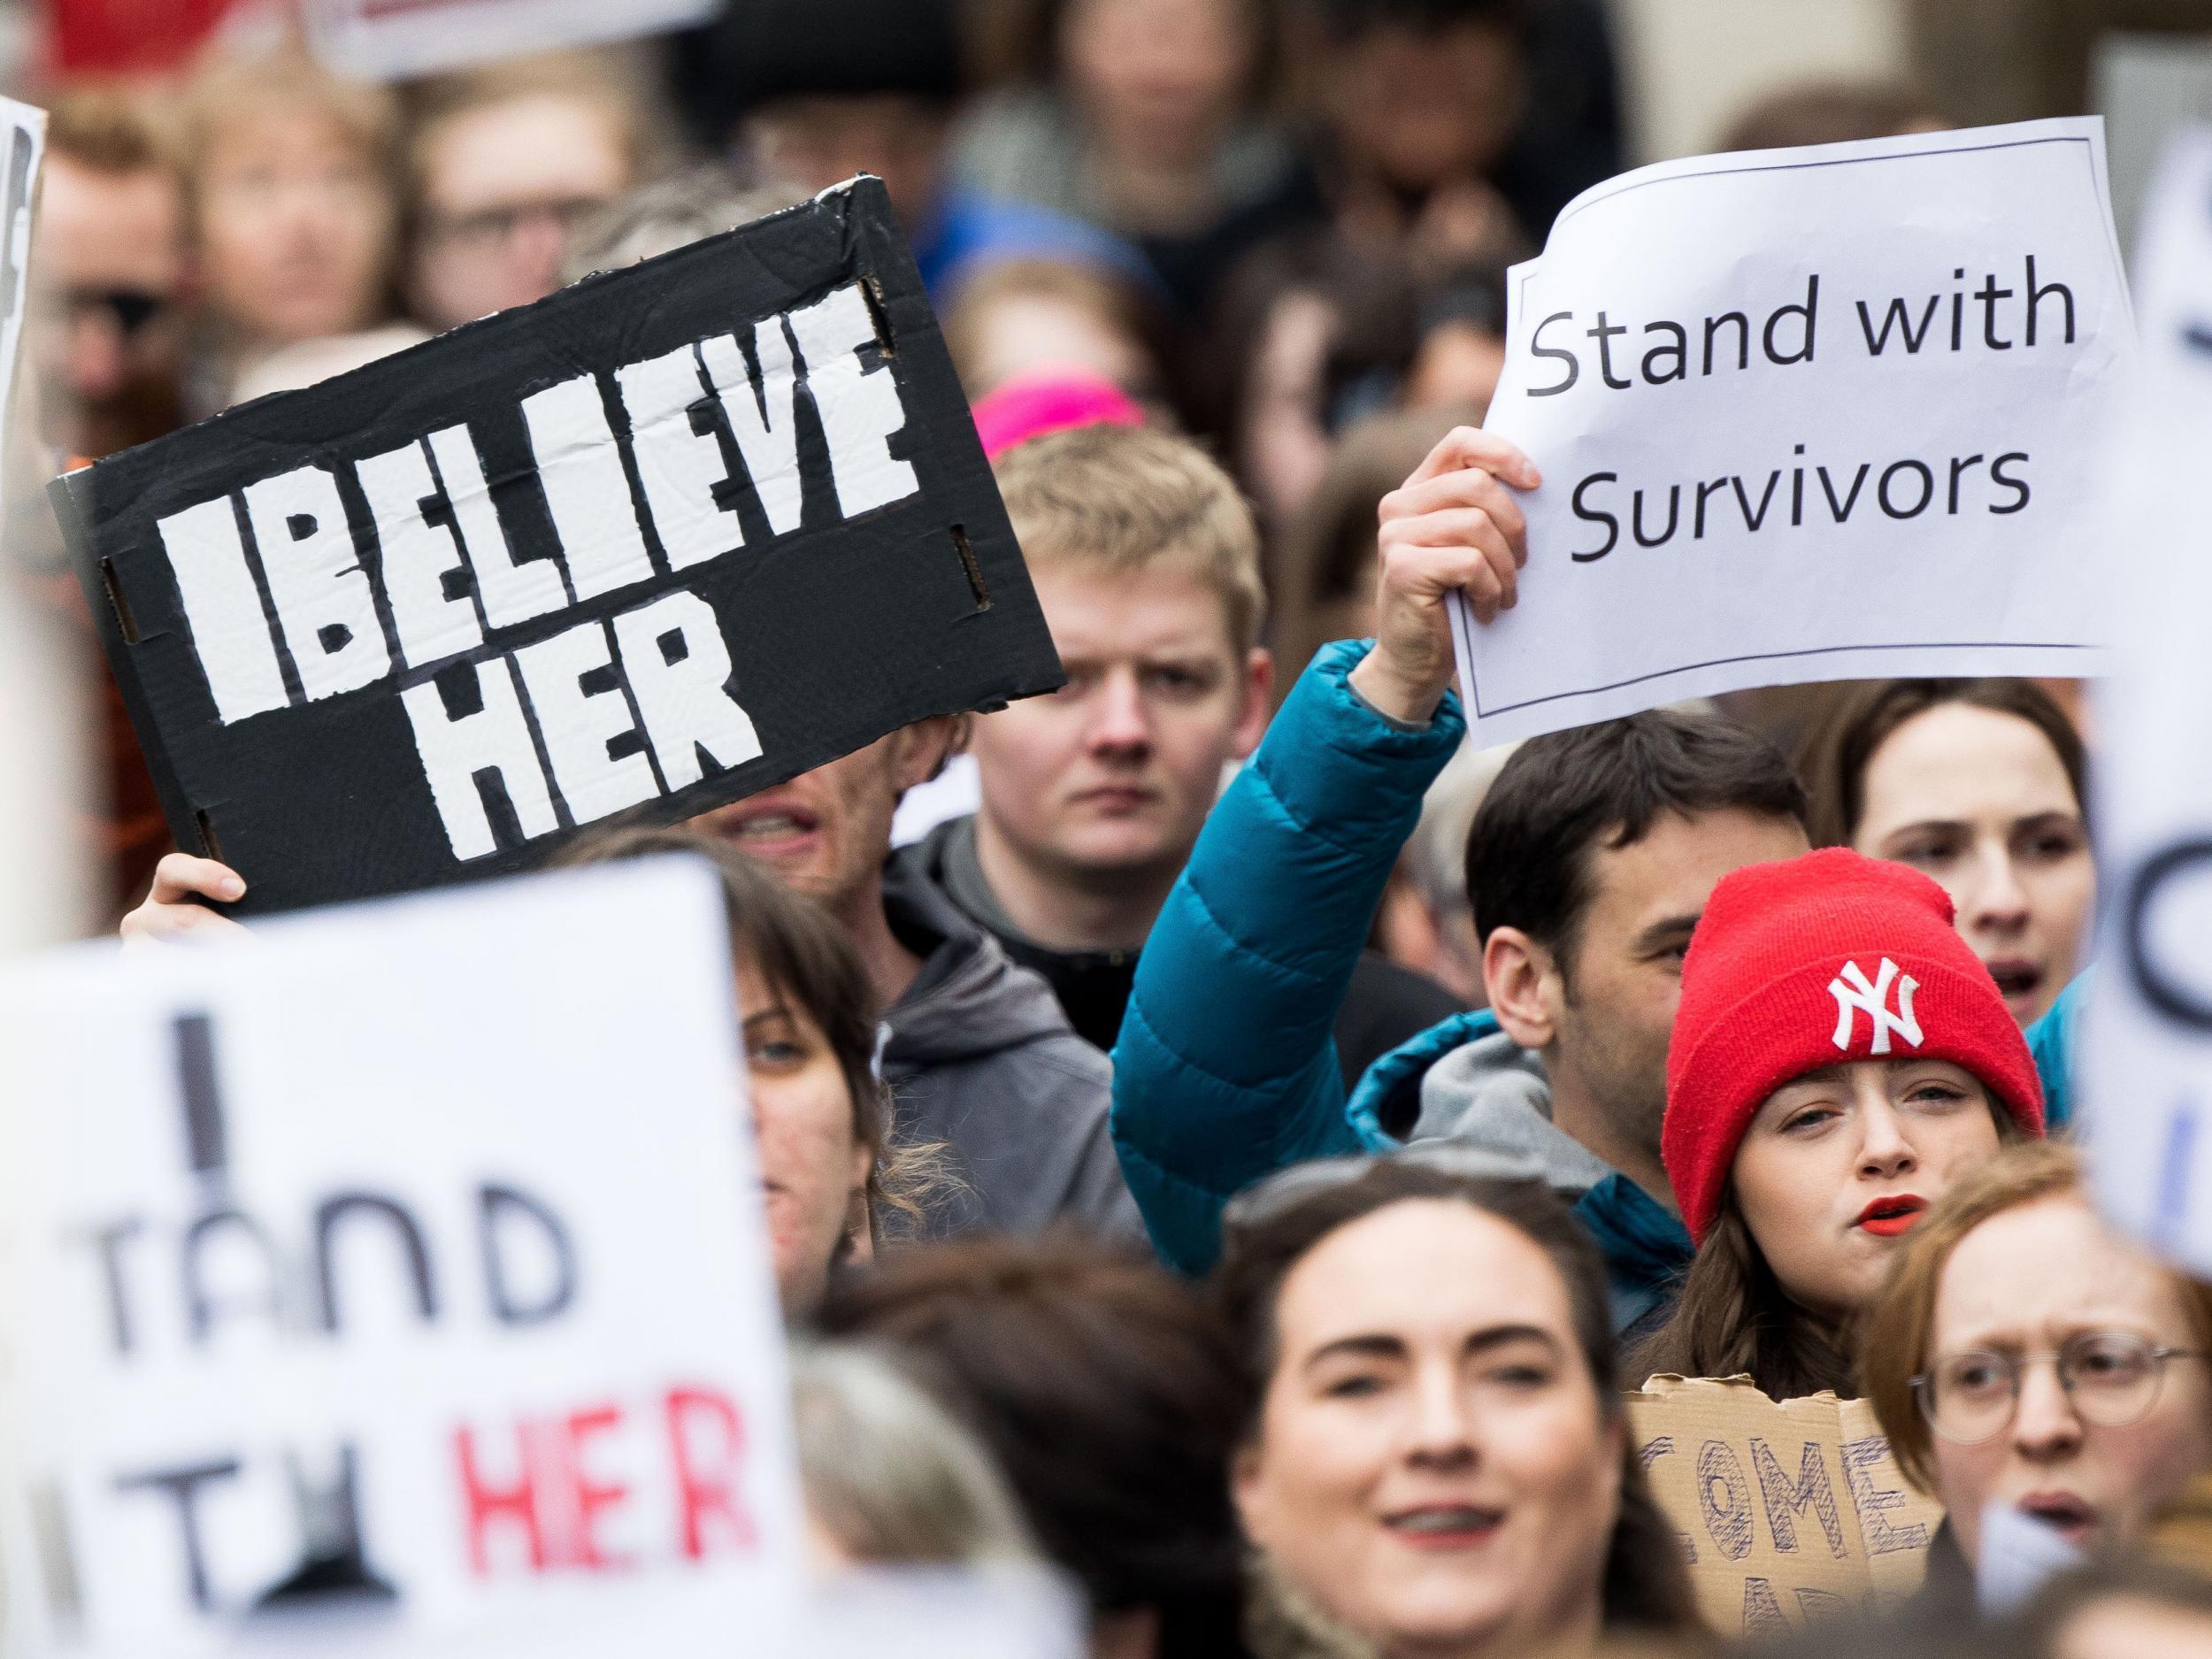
[1730,1060,1998,1318]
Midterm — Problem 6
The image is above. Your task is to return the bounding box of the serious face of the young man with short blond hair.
[972,562,1268,879]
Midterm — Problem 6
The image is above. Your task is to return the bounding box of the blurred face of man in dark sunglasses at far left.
[31,155,184,454]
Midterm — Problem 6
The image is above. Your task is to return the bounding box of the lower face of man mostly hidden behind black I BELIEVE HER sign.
[690,719,954,916]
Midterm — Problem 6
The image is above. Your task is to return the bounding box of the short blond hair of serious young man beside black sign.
[994,425,1268,653]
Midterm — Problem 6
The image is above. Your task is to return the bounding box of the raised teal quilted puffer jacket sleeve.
[1113,641,1467,1274]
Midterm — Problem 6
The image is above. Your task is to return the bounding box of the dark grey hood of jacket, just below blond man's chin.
[883,848,1069,1082]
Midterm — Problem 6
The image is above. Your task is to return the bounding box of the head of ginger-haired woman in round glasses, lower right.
[1861,1144,2212,1573]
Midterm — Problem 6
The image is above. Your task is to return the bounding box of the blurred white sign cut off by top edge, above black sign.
[305,0,721,80]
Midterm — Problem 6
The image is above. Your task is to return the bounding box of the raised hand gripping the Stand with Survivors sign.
[1352,427,1542,726]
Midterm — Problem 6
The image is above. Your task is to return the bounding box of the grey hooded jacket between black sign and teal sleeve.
[883,849,1146,1241]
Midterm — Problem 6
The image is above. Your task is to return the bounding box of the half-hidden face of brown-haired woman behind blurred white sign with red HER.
[737,967,872,1318]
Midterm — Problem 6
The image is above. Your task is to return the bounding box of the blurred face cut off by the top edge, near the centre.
[1060,0,1252,166]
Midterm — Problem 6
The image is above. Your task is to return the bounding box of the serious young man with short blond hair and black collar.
[898,425,1458,1075]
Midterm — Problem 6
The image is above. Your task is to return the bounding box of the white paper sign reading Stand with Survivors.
[1454,119,2132,743]
